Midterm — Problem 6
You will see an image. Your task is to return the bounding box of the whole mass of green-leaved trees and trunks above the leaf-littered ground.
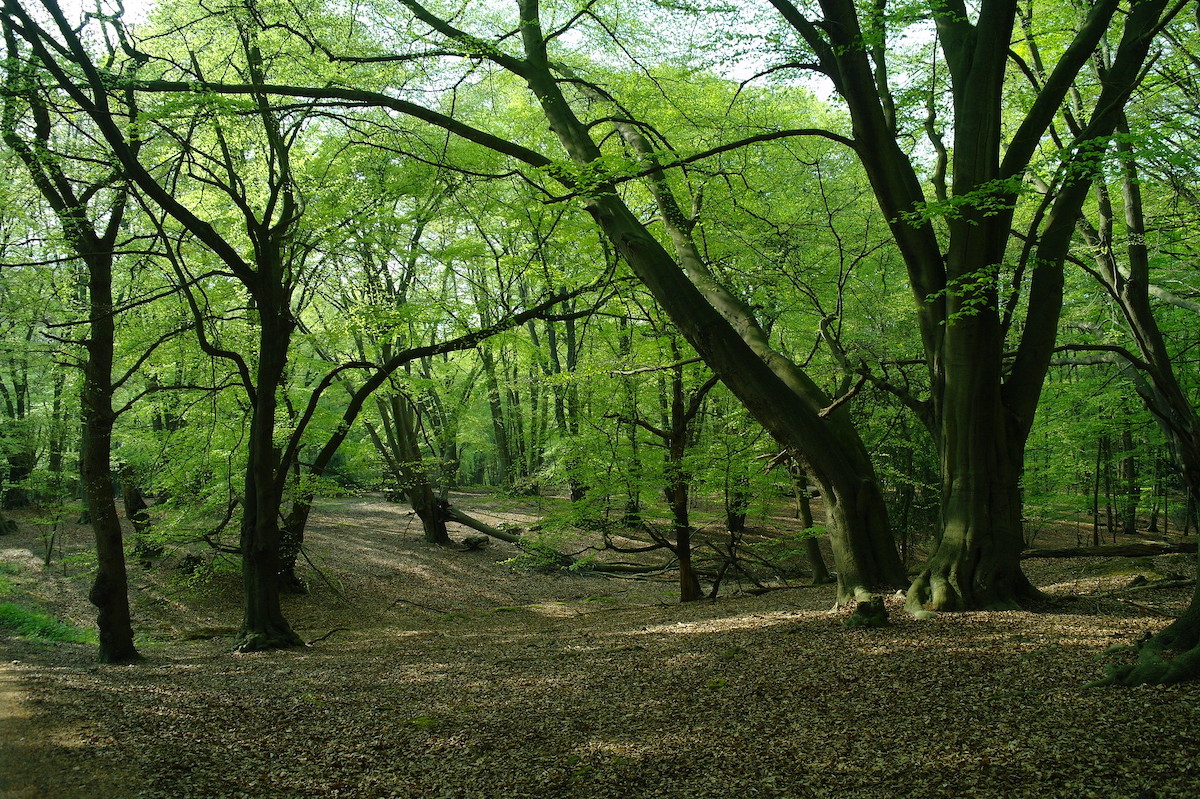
[0,0,1200,681]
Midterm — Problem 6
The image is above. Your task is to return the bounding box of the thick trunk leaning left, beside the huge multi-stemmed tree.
[501,0,908,602]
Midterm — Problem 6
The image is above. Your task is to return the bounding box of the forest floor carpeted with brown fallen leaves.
[0,498,1200,799]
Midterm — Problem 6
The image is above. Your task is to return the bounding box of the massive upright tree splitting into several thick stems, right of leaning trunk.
[753,0,1183,611]
